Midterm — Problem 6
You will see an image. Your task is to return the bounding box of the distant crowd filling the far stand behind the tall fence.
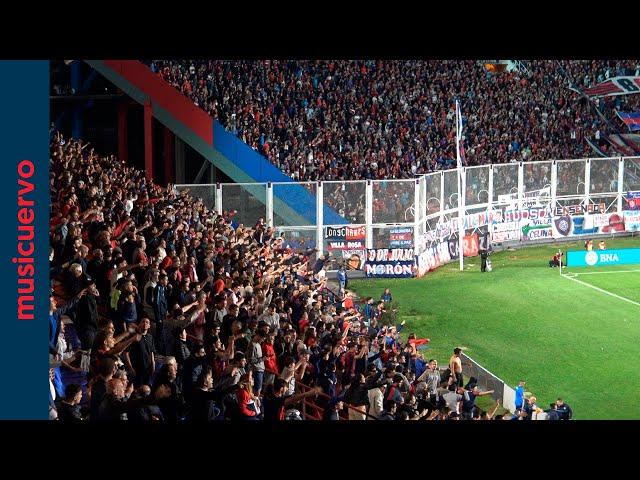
[149,60,640,180]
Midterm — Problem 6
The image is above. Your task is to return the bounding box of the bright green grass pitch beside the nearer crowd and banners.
[349,237,640,419]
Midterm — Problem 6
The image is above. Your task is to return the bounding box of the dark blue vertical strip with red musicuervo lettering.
[0,60,49,420]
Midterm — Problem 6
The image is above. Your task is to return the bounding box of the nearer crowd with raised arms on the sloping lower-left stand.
[49,133,570,423]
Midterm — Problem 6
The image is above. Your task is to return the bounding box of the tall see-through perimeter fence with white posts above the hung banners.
[175,157,640,262]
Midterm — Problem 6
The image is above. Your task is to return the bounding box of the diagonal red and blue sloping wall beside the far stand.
[85,60,350,225]
